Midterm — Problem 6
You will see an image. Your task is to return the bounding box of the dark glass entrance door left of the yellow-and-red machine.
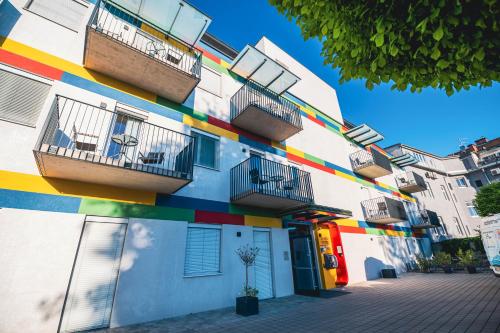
[290,225,319,295]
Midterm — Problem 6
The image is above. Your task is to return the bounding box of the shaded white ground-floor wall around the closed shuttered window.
[111,219,293,327]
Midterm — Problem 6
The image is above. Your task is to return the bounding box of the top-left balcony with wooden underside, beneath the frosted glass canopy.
[84,1,202,103]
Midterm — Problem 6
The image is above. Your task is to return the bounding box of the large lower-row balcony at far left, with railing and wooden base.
[34,96,195,194]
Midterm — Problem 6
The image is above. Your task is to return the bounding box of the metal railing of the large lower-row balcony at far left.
[38,96,195,180]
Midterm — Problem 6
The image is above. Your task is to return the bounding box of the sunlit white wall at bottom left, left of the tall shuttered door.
[0,208,84,333]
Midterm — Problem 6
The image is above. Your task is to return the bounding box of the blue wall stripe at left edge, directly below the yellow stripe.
[0,189,81,213]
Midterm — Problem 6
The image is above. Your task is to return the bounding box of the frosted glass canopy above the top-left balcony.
[110,0,212,46]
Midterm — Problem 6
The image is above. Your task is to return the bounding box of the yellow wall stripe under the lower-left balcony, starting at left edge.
[0,170,156,205]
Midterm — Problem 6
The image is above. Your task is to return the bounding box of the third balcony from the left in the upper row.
[350,149,392,179]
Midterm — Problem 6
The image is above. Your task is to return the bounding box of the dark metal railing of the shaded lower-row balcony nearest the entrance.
[230,156,314,203]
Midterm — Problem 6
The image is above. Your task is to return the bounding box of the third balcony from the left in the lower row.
[361,197,407,224]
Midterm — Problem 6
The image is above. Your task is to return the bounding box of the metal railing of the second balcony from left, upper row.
[231,81,302,130]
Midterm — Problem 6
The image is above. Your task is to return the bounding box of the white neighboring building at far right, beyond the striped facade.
[386,138,500,241]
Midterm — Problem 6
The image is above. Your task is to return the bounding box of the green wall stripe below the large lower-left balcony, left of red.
[78,198,194,222]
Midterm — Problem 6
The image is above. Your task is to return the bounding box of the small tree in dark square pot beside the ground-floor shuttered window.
[236,244,260,316]
